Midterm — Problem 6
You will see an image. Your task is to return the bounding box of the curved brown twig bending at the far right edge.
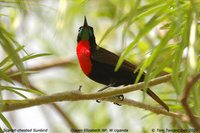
[181,74,200,129]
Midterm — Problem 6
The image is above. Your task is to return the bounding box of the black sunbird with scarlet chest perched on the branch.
[76,16,169,111]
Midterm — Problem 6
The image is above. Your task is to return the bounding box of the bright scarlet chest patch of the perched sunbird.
[76,40,92,75]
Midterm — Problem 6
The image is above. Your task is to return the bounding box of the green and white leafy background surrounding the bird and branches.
[0,0,200,133]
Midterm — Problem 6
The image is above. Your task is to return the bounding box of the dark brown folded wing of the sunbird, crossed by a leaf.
[91,47,136,72]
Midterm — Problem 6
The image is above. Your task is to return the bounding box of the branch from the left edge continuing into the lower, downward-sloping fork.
[2,91,198,122]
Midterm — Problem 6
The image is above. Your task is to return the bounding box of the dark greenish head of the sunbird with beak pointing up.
[77,17,94,42]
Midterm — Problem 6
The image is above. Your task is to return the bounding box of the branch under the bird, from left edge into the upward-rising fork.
[2,75,171,111]
